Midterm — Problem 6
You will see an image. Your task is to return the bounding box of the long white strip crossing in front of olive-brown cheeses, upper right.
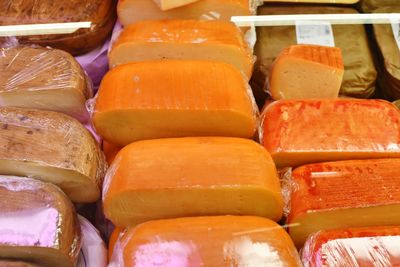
[231,13,400,27]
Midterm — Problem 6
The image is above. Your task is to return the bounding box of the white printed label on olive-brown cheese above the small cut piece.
[296,21,335,47]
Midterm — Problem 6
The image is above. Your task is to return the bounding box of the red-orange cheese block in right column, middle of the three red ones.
[288,159,400,247]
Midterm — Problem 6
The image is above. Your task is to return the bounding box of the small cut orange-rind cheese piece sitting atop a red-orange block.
[269,45,344,99]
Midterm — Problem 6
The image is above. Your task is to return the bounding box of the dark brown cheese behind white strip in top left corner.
[0,0,116,55]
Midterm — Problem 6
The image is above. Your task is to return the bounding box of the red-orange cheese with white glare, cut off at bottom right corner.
[302,226,400,267]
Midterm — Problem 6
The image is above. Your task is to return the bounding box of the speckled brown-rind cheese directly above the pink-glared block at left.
[0,107,106,202]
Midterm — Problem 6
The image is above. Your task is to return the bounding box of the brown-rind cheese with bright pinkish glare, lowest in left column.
[0,176,80,267]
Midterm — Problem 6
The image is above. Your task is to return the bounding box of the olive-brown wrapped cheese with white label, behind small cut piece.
[255,5,377,102]
